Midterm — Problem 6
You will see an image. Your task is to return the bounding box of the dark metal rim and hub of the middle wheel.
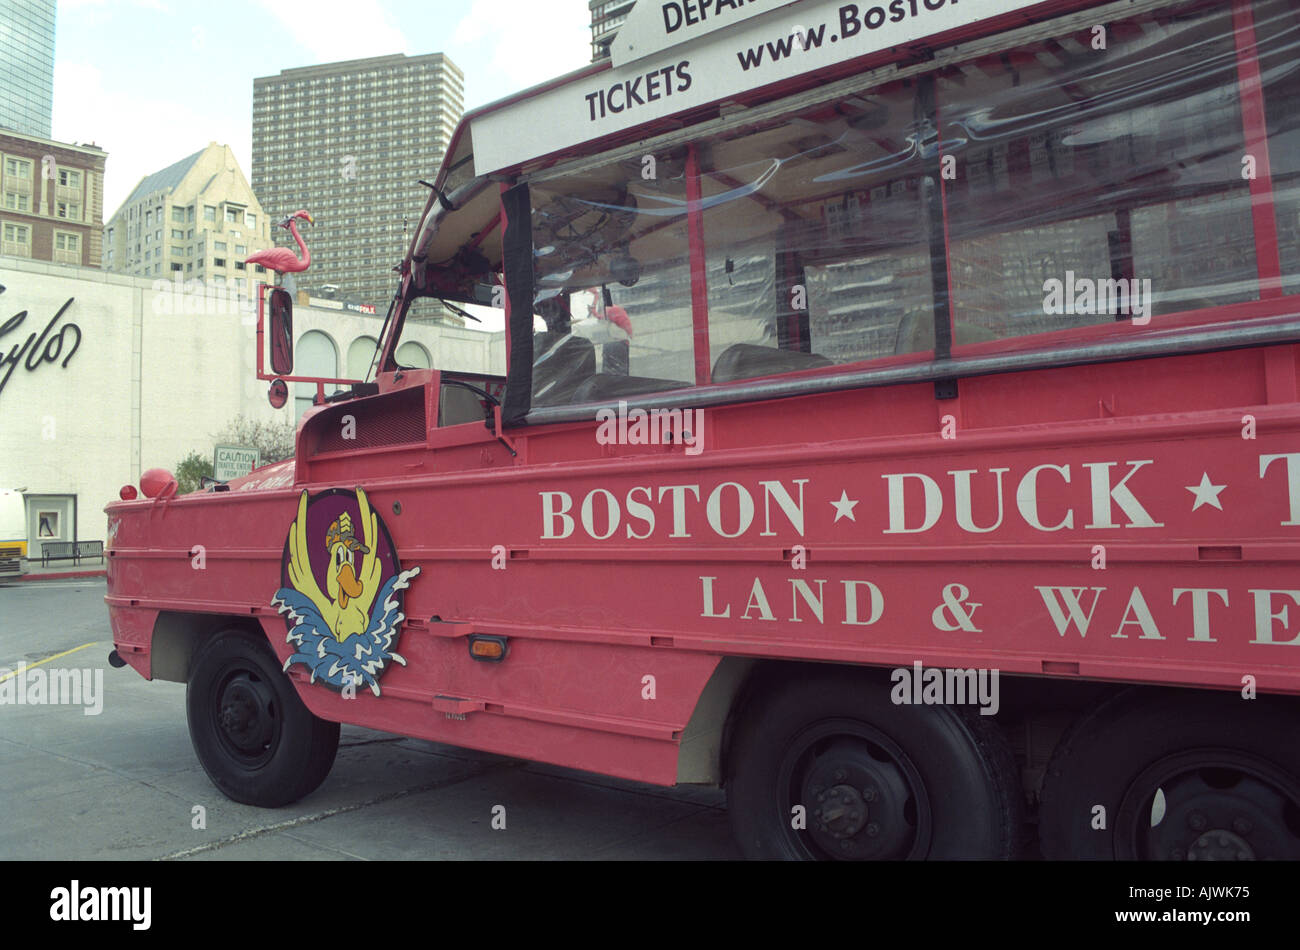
[776,719,933,860]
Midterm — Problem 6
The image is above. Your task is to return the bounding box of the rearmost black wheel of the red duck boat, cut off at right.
[1039,690,1300,860]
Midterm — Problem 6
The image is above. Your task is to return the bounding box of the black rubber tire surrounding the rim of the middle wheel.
[727,667,1023,860]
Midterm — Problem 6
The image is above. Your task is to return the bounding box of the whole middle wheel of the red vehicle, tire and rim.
[727,671,1022,860]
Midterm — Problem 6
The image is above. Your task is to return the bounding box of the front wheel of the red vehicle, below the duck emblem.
[185,630,338,808]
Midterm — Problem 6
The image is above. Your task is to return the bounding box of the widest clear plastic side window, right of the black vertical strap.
[937,4,1258,343]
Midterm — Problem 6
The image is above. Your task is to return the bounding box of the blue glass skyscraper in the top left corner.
[0,0,55,139]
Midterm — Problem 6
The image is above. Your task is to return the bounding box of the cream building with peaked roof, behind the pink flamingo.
[104,142,274,294]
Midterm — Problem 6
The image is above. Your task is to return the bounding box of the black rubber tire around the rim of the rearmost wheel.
[1039,689,1300,860]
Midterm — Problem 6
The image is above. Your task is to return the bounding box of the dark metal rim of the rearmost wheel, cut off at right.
[1115,749,1300,860]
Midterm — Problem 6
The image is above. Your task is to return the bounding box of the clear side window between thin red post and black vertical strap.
[699,83,935,382]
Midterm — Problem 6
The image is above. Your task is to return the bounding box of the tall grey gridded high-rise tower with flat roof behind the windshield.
[252,53,464,308]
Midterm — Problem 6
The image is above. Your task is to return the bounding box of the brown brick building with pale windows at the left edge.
[0,130,108,268]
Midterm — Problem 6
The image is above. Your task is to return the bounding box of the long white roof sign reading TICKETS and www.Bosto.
[471,0,1043,174]
